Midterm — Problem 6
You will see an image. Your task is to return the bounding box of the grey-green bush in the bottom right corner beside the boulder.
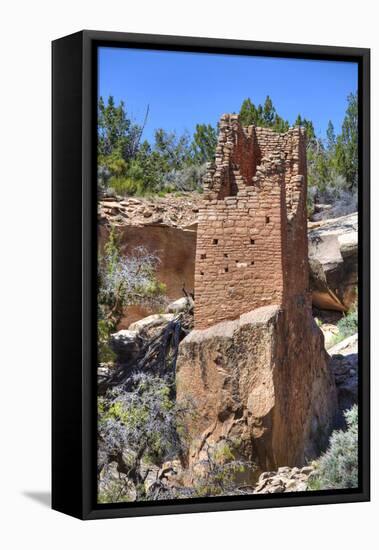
[308,405,358,490]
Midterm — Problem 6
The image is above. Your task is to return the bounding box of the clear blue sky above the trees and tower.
[99,48,358,141]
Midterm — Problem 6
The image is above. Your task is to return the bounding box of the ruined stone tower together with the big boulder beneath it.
[176,115,336,471]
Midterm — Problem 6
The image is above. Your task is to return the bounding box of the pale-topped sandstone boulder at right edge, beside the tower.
[308,213,358,311]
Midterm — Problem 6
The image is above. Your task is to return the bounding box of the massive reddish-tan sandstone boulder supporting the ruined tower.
[176,303,336,470]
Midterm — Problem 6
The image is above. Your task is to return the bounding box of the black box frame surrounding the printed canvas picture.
[52,30,370,519]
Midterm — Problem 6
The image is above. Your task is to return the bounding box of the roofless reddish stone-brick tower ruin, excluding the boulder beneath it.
[195,111,309,329]
